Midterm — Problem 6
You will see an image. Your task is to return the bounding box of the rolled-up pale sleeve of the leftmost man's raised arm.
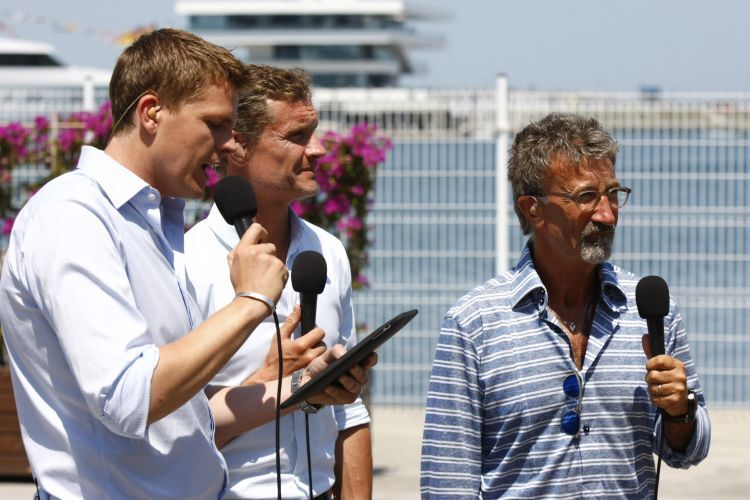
[22,200,159,438]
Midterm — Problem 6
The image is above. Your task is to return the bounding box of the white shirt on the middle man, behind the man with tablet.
[185,206,370,499]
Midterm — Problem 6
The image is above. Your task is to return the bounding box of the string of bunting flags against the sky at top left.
[0,8,163,46]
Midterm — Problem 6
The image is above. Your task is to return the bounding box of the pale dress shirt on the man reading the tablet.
[0,147,226,498]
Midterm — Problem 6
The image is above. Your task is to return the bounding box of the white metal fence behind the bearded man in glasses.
[0,78,750,407]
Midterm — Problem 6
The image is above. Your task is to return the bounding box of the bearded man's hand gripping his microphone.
[641,335,688,416]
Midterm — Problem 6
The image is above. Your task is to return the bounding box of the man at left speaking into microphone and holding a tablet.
[0,29,372,498]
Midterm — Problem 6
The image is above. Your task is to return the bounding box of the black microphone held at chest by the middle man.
[292,250,328,335]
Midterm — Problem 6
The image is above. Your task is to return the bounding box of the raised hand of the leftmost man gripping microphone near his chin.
[227,224,289,312]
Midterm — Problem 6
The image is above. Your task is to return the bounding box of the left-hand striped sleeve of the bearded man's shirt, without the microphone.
[421,315,482,498]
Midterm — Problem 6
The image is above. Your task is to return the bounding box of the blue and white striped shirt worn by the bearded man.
[421,245,710,498]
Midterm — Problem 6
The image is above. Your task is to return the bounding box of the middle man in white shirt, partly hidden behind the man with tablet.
[185,66,372,498]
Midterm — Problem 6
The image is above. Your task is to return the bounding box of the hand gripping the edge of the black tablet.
[300,344,378,405]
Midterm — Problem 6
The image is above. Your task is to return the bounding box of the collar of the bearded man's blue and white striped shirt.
[511,240,627,311]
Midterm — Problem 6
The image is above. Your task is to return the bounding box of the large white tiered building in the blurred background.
[175,0,442,87]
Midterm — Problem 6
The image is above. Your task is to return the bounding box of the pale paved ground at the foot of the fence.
[0,408,750,500]
